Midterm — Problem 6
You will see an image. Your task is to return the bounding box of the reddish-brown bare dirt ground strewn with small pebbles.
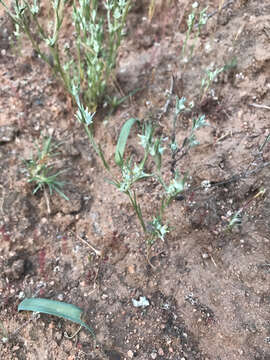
[0,0,270,360]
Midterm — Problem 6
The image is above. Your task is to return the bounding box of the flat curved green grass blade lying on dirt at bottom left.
[18,298,95,336]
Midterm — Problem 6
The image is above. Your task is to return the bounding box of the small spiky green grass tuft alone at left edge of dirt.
[24,137,69,200]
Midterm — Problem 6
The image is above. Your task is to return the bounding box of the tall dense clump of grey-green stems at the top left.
[0,0,131,110]
